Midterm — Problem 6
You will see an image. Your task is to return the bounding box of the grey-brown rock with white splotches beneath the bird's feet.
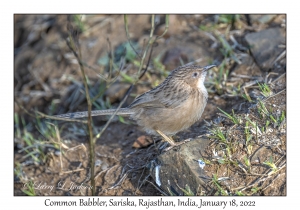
[151,138,209,195]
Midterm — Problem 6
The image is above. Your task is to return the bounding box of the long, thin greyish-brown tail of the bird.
[54,108,133,119]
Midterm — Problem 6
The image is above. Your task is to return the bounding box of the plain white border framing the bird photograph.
[0,0,300,210]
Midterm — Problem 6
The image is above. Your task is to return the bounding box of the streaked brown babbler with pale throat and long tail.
[55,65,216,147]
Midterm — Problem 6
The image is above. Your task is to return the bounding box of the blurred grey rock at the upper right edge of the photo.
[245,28,285,71]
